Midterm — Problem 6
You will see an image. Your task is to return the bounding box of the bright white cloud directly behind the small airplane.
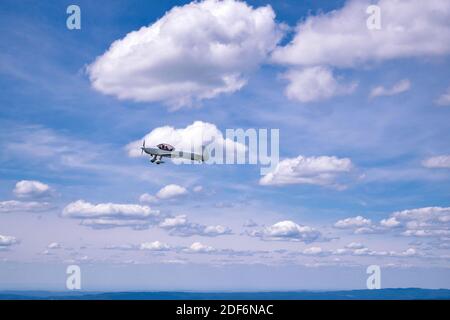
[125,121,246,161]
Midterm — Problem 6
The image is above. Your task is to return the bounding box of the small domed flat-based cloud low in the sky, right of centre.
[248,220,321,243]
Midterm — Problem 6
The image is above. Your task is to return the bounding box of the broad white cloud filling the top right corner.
[273,0,450,67]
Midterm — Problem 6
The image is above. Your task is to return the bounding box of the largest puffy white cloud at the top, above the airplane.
[87,0,282,108]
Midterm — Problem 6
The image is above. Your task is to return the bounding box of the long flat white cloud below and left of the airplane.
[62,200,159,229]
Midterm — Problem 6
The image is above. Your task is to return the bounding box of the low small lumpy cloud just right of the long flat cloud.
[159,215,232,237]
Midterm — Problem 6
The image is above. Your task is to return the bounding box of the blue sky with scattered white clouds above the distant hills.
[0,1,450,290]
